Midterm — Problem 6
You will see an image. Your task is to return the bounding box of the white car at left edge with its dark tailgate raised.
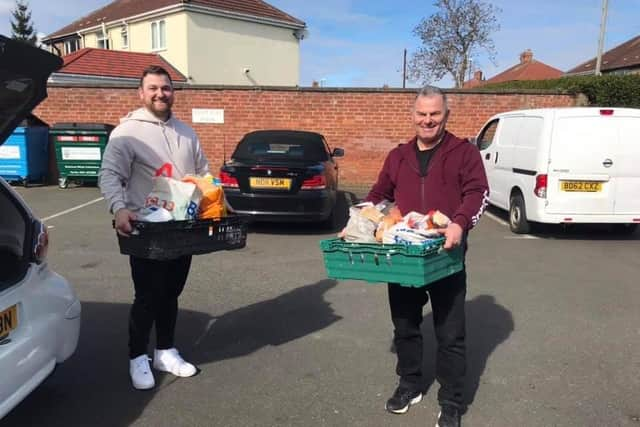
[0,35,81,418]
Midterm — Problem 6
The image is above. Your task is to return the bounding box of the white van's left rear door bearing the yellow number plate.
[546,108,638,215]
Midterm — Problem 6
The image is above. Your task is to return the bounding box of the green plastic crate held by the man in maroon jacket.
[320,238,463,287]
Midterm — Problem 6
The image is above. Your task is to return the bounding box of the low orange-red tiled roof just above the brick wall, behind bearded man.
[57,48,187,82]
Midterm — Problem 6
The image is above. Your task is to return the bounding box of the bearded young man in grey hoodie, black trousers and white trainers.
[99,66,208,390]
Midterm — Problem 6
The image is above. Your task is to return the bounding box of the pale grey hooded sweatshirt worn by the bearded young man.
[99,108,209,213]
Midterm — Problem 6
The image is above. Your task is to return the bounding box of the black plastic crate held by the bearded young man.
[118,215,247,260]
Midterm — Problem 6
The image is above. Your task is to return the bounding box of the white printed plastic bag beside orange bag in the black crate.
[140,176,202,221]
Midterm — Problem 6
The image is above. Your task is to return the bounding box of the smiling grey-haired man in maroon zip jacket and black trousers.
[366,86,489,427]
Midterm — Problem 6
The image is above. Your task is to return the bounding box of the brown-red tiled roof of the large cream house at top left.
[43,0,305,41]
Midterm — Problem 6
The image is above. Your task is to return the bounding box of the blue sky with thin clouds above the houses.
[0,0,640,87]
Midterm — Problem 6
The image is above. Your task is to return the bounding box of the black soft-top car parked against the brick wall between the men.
[220,130,344,228]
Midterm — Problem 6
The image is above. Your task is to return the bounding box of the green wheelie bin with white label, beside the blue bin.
[49,123,114,188]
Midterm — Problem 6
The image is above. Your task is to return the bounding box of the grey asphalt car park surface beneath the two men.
[2,187,640,427]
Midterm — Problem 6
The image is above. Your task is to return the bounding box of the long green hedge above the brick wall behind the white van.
[476,74,640,108]
